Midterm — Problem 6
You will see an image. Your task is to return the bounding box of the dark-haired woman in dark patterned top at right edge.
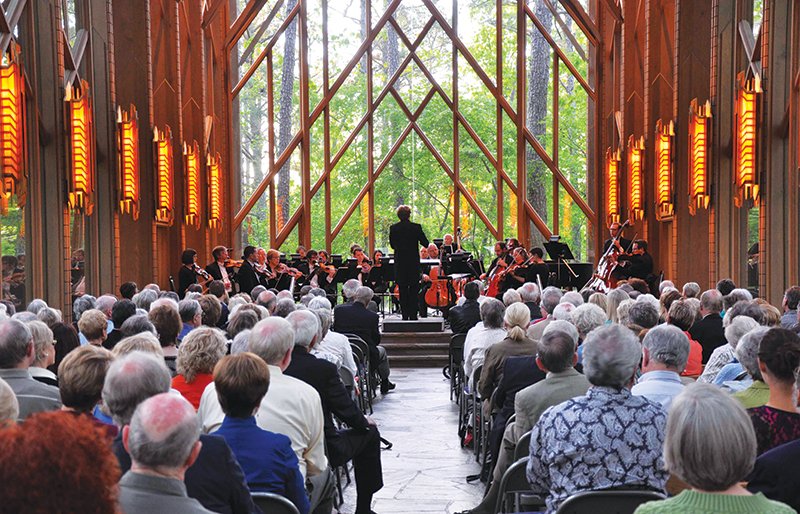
[748,328,800,455]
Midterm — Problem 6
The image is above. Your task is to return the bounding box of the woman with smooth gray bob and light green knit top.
[636,384,794,514]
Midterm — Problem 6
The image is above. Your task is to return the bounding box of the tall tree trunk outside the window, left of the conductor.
[275,0,297,226]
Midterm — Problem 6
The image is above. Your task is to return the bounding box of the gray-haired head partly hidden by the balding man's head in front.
[103,352,172,427]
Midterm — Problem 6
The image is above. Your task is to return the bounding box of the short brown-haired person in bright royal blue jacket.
[214,353,309,514]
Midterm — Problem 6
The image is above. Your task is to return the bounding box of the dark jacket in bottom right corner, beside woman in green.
[747,434,800,510]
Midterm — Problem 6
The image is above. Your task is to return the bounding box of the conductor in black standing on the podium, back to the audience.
[389,205,428,320]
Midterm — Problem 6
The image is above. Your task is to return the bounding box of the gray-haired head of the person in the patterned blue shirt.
[583,324,642,388]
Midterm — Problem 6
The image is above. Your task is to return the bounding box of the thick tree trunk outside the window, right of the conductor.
[524,2,558,227]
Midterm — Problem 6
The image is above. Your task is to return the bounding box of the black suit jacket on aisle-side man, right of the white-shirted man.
[283,346,369,441]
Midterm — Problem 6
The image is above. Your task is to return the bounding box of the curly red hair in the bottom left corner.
[0,412,120,514]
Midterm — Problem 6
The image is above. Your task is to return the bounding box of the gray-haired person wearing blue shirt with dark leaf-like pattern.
[527,324,667,512]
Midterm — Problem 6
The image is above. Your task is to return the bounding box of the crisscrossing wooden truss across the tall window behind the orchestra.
[225,0,601,249]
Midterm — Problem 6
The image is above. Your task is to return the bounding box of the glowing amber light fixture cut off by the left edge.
[0,43,25,205]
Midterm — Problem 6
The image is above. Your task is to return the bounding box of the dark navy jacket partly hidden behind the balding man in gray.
[111,430,259,514]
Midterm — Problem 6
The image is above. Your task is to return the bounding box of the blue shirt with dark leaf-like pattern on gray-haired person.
[527,386,668,513]
